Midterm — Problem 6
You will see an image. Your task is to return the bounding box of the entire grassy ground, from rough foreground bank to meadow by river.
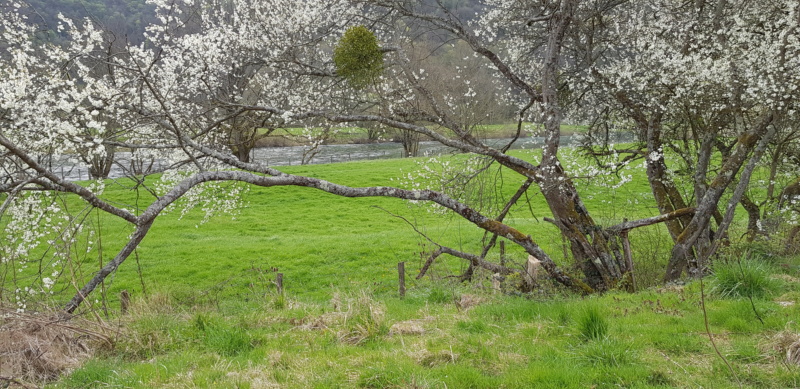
[34,148,800,388]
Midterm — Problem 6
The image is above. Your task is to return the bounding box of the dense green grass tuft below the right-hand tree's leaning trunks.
[712,258,778,298]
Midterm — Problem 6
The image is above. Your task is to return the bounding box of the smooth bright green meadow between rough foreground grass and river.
[61,148,659,299]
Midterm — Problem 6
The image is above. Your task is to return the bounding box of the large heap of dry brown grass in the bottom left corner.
[0,309,113,387]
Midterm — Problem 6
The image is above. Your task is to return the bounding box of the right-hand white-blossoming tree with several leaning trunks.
[585,1,800,281]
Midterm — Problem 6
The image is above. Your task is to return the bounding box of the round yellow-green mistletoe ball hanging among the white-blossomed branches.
[333,26,383,89]
